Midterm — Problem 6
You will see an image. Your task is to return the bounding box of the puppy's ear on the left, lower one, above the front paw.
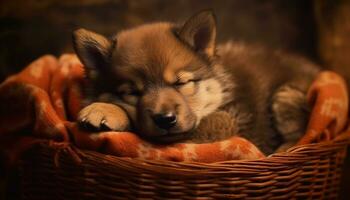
[73,29,116,70]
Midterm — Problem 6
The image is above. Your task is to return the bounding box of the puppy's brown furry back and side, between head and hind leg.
[218,42,319,153]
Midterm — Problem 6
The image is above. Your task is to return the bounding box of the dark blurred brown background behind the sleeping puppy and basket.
[0,0,350,199]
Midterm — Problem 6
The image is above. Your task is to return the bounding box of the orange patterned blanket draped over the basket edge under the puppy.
[0,54,348,162]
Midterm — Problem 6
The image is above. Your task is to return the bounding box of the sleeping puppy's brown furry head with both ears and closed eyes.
[73,11,221,142]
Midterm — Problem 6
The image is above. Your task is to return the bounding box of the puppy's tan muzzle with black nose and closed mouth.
[137,87,196,142]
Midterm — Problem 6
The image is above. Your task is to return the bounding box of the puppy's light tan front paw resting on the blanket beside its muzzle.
[78,103,130,131]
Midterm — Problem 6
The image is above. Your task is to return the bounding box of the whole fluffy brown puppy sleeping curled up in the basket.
[73,11,318,154]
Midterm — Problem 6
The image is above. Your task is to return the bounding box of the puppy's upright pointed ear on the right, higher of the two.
[178,10,216,57]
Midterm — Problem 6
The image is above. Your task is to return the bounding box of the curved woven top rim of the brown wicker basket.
[24,131,350,178]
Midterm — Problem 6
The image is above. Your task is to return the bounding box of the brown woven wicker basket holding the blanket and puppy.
[20,132,349,200]
